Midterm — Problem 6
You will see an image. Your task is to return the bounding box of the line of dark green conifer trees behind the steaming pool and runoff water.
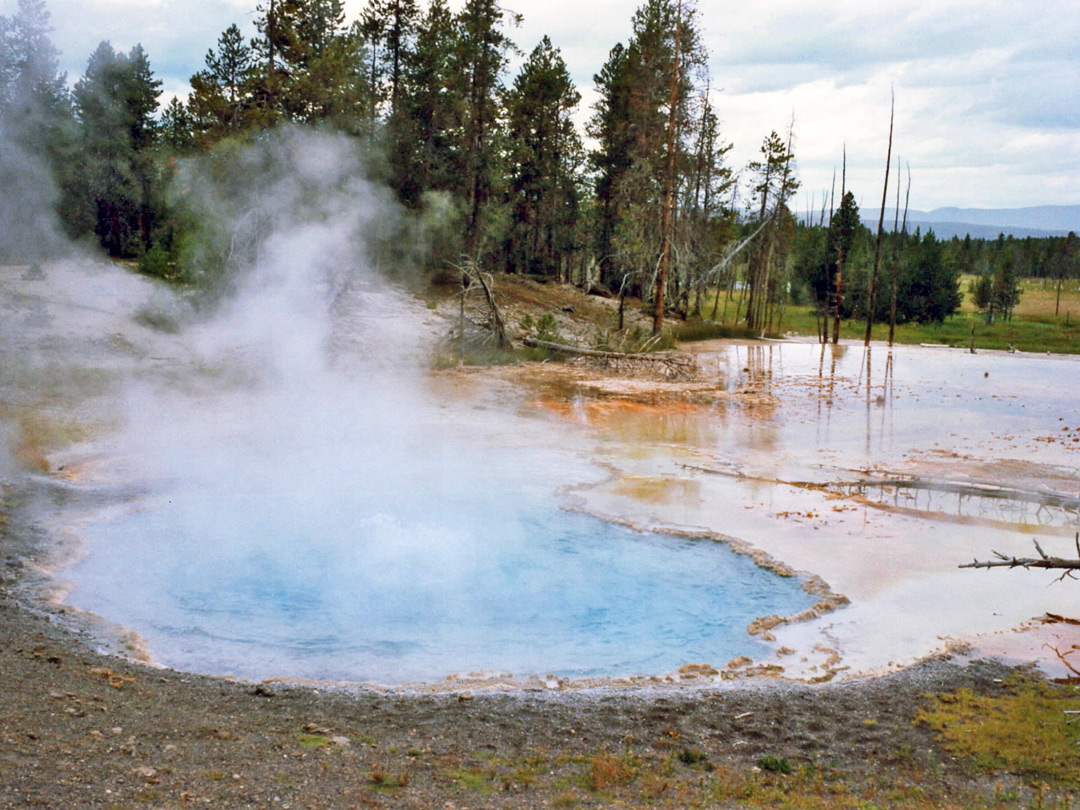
[0,0,1077,335]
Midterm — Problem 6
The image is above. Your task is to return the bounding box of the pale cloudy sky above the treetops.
[23,0,1080,210]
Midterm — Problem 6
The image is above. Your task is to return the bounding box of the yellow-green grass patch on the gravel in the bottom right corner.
[916,678,1080,787]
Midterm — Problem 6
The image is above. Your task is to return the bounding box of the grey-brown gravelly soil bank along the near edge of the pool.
[0,578,1071,810]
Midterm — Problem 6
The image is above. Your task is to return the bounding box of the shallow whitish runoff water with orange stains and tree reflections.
[579,342,1080,677]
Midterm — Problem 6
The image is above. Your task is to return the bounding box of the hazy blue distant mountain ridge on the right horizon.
[862,205,1080,239]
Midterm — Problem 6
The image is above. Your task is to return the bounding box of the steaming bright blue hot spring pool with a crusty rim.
[70,497,814,685]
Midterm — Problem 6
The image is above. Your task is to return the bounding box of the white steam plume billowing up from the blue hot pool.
[62,130,587,675]
